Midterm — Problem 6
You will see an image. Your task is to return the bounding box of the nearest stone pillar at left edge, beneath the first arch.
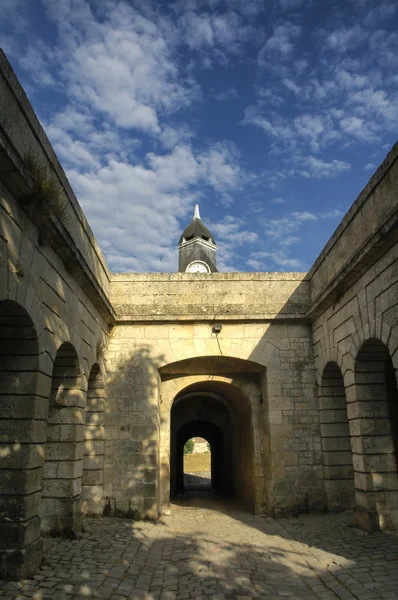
[0,373,48,579]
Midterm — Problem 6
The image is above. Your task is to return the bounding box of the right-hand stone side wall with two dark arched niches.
[308,144,398,530]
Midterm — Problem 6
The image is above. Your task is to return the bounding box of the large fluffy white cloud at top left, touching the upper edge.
[40,0,197,134]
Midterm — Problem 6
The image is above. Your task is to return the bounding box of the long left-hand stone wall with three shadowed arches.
[0,50,114,578]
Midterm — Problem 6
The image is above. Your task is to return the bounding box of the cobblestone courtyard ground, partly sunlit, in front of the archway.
[0,498,398,600]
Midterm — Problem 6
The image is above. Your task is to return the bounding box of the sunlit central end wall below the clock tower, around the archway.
[105,273,323,514]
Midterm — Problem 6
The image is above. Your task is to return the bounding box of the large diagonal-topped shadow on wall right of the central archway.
[243,277,327,517]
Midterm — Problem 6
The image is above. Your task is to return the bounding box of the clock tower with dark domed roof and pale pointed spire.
[178,204,217,273]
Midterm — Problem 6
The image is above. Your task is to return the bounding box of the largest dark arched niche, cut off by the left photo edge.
[0,300,43,579]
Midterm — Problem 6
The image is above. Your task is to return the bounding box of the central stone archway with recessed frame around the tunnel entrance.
[159,357,264,513]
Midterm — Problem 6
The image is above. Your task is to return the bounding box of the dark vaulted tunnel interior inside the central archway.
[170,384,253,510]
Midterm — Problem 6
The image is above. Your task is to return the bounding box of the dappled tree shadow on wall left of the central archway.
[104,342,166,518]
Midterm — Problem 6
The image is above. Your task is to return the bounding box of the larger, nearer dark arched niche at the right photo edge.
[347,338,398,531]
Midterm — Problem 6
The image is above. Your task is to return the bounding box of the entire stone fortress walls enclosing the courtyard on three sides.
[0,55,398,579]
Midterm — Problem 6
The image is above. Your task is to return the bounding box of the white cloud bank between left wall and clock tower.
[68,144,244,271]
